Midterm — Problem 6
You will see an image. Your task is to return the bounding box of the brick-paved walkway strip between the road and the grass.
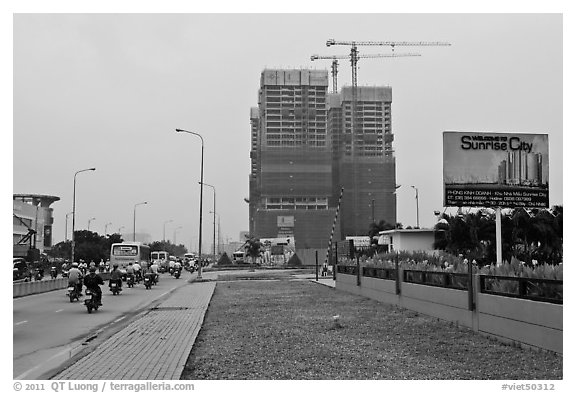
[52,282,216,380]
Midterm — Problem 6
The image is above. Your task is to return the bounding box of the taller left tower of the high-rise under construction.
[249,69,335,248]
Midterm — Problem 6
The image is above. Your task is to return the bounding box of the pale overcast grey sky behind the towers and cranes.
[13,13,563,248]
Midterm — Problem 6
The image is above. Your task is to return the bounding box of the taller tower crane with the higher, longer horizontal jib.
[326,39,451,236]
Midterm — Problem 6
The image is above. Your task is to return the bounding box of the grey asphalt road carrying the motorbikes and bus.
[13,270,192,379]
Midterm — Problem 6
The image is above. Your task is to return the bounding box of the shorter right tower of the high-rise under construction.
[328,87,396,236]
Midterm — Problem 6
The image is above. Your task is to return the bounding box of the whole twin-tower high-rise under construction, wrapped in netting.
[249,69,396,249]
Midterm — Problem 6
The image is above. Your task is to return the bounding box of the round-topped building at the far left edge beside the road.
[12,194,60,257]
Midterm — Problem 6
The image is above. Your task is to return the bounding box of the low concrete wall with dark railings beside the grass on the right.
[336,272,563,353]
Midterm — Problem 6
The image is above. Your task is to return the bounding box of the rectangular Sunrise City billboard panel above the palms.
[443,131,549,208]
